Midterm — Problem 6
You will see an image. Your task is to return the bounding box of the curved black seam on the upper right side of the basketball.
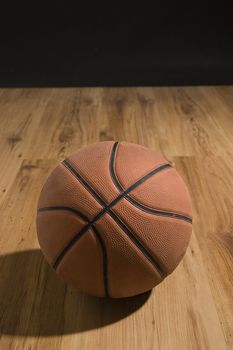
[110,142,192,223]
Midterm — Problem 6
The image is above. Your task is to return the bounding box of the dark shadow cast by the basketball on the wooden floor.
[0,250,150,336]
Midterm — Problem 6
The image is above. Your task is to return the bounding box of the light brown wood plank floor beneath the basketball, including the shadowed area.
[0,87,233,350]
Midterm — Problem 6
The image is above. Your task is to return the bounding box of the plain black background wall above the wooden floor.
[0,0,233,87]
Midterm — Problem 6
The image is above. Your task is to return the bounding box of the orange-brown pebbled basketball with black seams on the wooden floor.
[37,141,192,298]
